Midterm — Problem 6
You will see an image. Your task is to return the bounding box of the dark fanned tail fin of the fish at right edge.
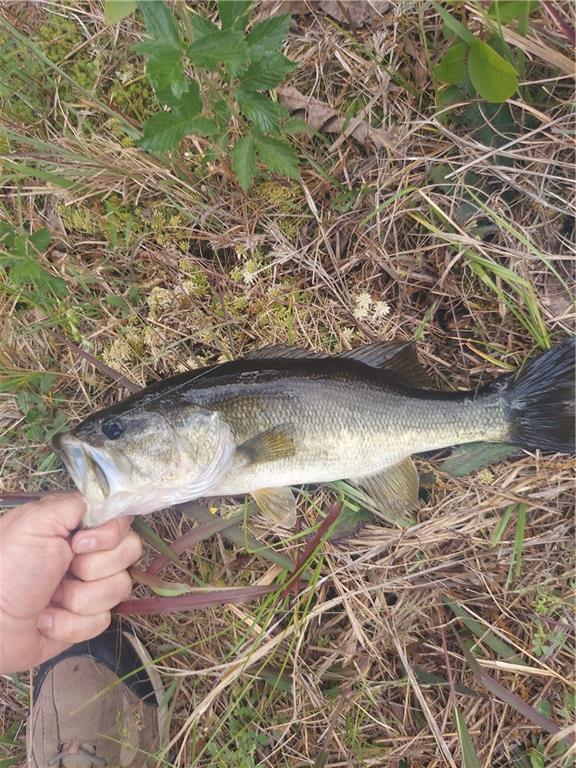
[505,337,576,454]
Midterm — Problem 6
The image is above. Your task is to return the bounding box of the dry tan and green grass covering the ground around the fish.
[0,0,575,768]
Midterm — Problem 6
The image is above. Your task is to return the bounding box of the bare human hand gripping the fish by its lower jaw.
[0,493,142,673]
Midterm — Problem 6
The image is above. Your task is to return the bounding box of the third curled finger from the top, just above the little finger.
[52,571,132,616]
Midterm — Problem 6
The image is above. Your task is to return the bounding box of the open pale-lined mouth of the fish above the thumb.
[52,433,110,500]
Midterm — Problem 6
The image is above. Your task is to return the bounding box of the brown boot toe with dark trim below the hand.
[27,620,166,768]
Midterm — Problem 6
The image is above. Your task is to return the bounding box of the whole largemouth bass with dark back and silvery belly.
[53,337,576,527]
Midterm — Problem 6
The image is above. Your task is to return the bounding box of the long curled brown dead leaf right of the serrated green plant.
[278,87,397,152]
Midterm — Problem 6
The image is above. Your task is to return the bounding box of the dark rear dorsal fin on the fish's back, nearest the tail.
[338,341,434,389]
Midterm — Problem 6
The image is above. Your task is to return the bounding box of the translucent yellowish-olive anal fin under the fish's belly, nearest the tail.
[353,457,418,518]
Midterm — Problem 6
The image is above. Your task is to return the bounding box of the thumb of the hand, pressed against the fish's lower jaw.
[20,491,86,538]
